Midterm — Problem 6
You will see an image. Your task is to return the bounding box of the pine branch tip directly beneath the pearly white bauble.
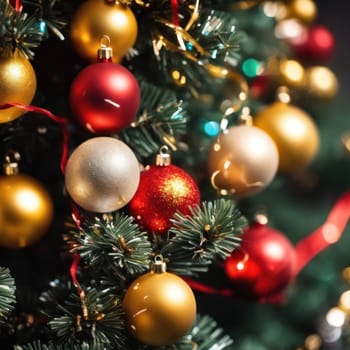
[66,212,152,280]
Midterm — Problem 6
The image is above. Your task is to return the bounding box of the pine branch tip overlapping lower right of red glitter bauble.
[161,199,247,276]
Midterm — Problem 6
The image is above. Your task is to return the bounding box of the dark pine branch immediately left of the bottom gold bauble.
[49,289,126,349]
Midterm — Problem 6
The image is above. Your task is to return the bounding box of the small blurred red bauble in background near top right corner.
[289,25,335,63]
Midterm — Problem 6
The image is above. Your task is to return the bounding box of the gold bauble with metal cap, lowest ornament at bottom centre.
[123,256,197,346]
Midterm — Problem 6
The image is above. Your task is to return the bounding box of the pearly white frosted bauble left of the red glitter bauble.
[65,136,140,213]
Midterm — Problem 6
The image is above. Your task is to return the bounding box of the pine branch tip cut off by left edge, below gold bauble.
[0,267,16,326]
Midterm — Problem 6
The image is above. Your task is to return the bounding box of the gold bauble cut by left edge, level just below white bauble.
[0,174,53,248]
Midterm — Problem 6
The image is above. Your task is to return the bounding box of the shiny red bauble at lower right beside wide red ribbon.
[224,219,295,301]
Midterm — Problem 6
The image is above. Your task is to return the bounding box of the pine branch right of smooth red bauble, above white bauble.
[121,80,187,158]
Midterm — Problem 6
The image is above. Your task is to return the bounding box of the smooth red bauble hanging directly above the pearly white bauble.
[69,62,140,133]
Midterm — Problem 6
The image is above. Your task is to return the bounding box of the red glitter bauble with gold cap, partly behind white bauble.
[128,146,200,235]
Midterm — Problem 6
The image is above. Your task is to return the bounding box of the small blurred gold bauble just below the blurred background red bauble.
[305,66,338,101]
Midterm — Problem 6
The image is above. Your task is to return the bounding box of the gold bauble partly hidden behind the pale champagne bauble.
[254,101,319,172]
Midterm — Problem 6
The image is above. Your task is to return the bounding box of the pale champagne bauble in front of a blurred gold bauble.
[208,125,278,197]
